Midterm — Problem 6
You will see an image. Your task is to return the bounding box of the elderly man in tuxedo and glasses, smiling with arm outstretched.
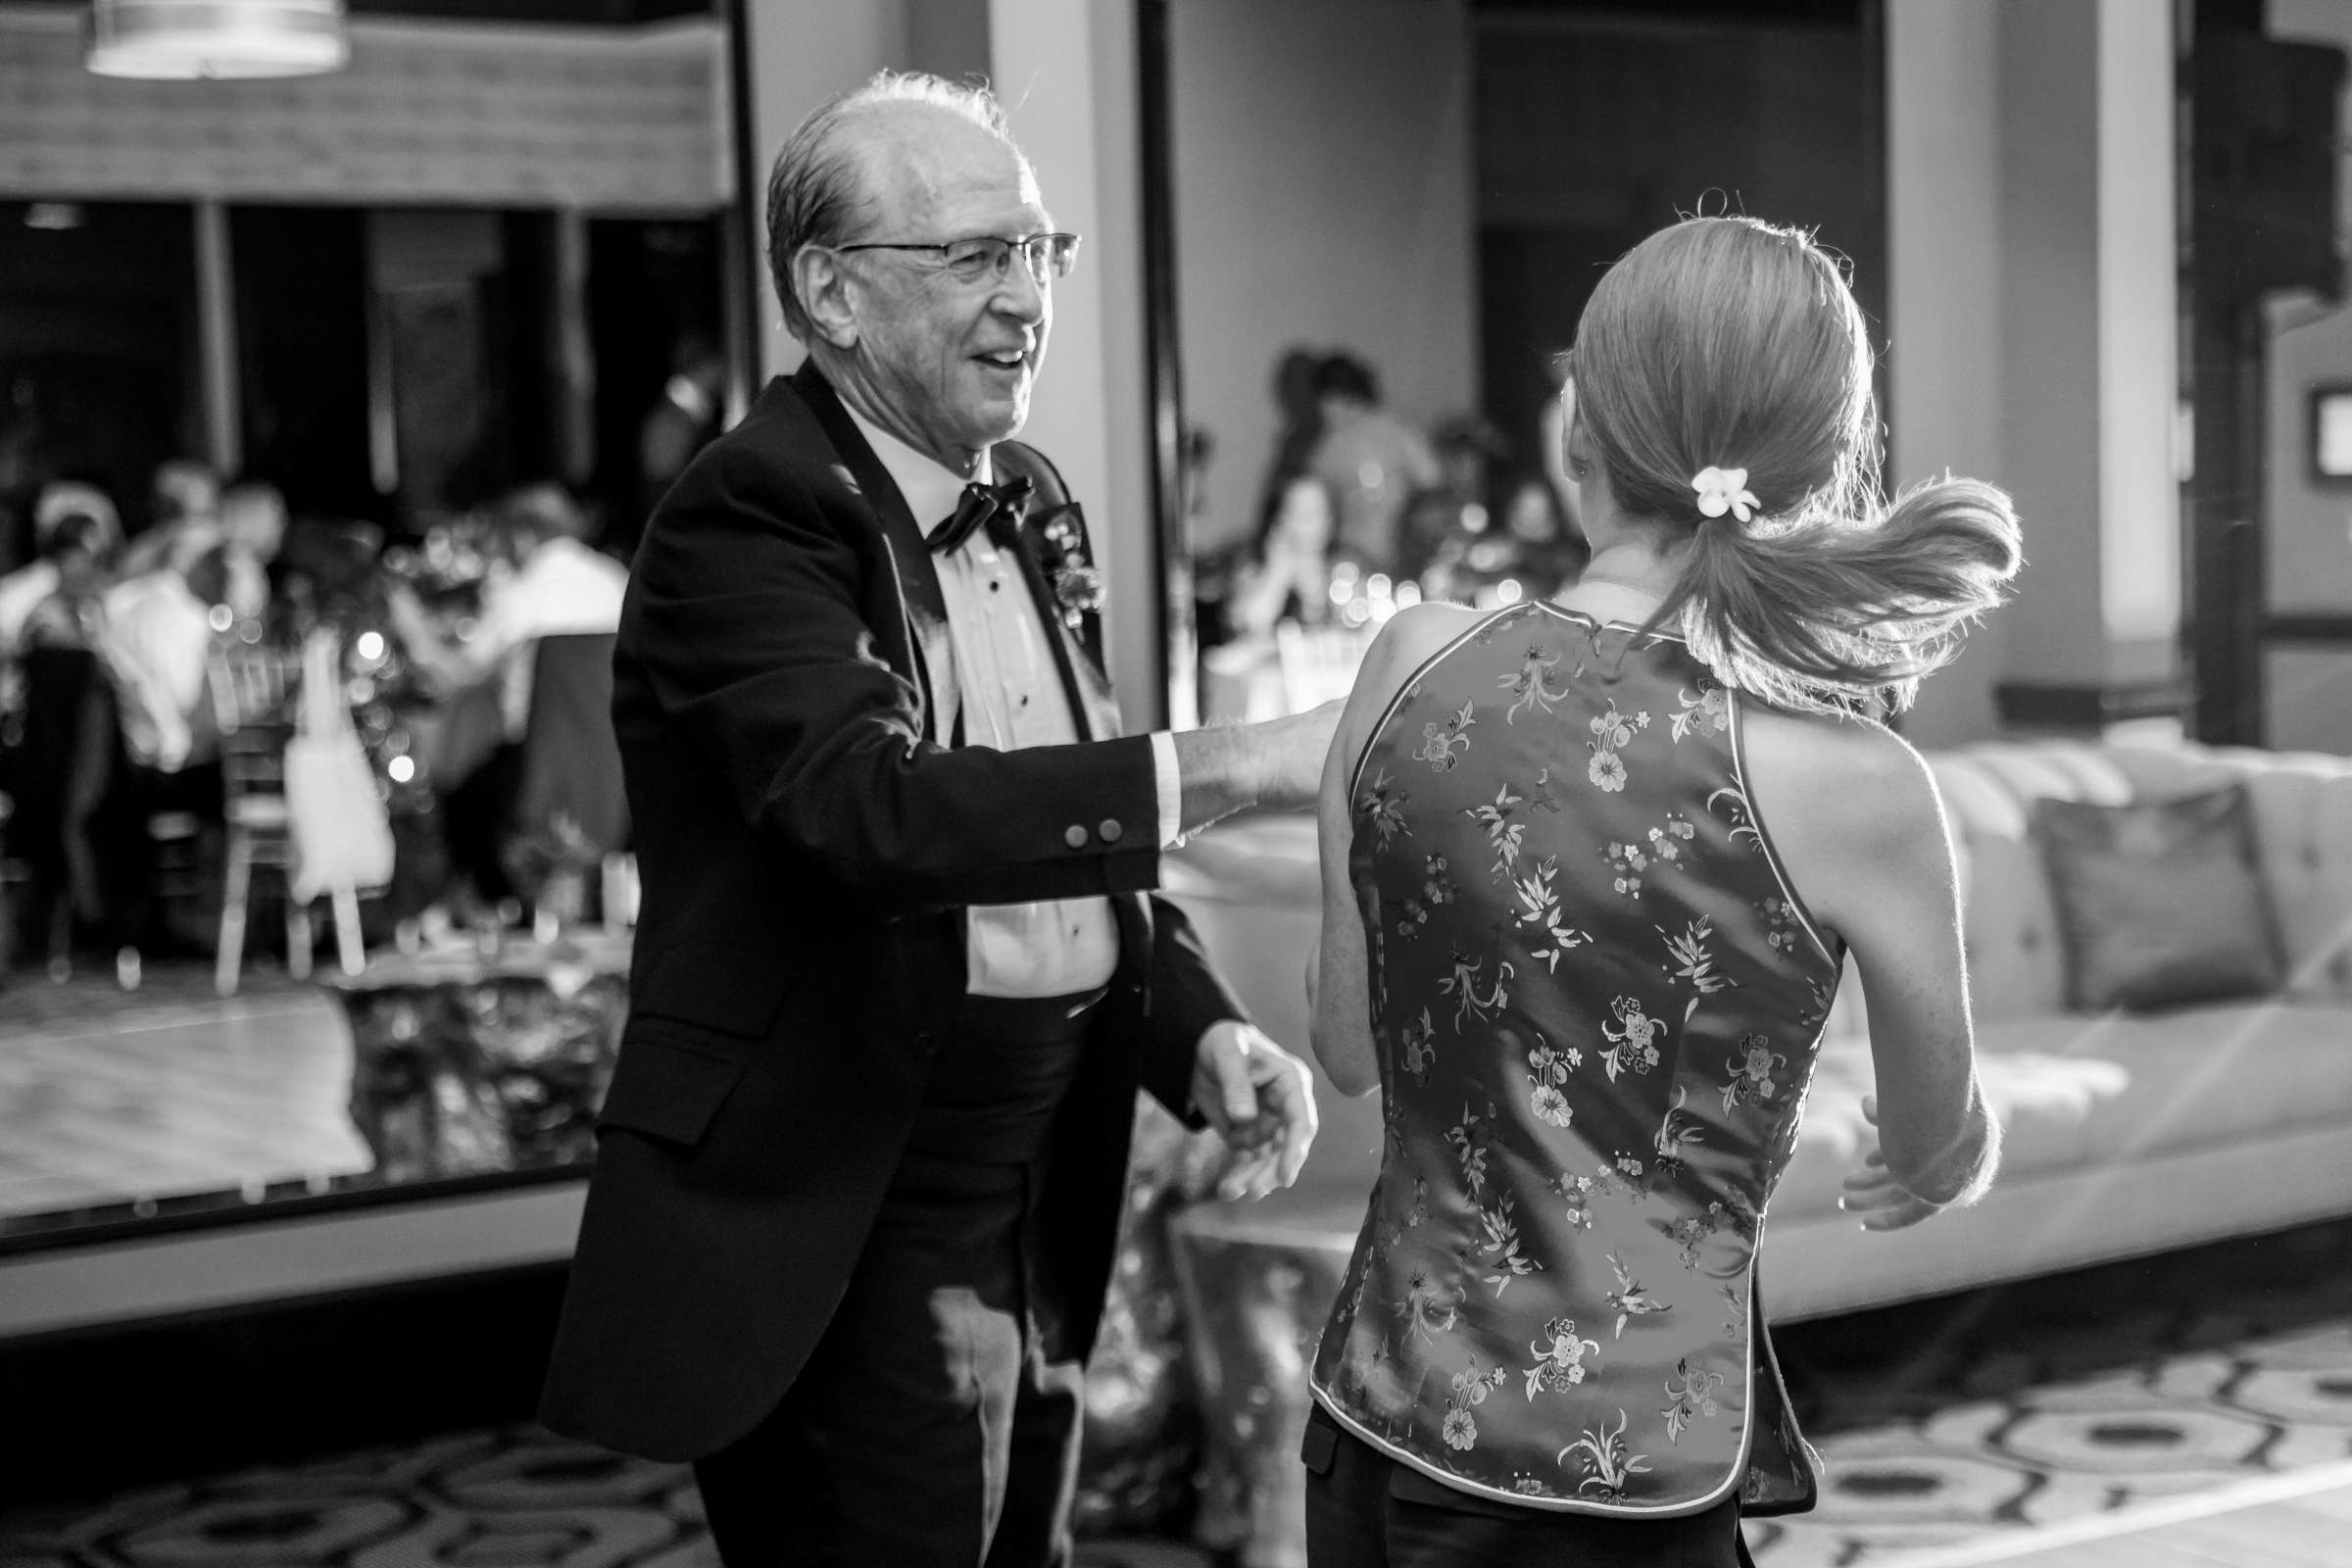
[543,75,1334,1568]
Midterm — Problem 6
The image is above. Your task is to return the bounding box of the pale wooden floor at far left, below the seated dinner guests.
[0,980,371,1213]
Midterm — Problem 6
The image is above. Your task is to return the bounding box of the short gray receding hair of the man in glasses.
[766,71,1021,343]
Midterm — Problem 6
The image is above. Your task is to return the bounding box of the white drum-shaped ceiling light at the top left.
[84,0,351,80]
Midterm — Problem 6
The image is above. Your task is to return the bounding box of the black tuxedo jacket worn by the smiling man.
[541,369,1242,1460]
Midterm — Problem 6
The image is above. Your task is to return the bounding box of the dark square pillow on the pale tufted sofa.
[2034,785,2286,1013]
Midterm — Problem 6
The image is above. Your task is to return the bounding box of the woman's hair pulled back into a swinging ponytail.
[1571,219,2021,710]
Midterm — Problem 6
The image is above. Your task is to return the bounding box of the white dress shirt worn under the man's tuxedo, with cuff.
[845,405,1183,997]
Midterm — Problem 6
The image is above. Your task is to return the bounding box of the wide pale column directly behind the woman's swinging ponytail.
[1886,0,2180,745]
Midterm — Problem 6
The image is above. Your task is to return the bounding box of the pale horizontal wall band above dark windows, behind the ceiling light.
[0,7,734,212]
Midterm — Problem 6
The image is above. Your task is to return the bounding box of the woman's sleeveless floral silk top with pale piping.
[1312,604,1841,1516]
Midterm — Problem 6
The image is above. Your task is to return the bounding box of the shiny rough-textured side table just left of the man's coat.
[327,931,630,1183]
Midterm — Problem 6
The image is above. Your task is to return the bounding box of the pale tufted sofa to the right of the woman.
[1764,741,2352,1316]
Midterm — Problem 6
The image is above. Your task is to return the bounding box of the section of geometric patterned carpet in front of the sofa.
[1747,1220,2352,1568]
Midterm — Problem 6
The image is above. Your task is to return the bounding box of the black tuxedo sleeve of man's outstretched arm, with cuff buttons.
[613,434,1159,917]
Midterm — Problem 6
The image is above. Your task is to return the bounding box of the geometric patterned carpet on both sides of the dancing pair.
[0,1225,2352,1568]
